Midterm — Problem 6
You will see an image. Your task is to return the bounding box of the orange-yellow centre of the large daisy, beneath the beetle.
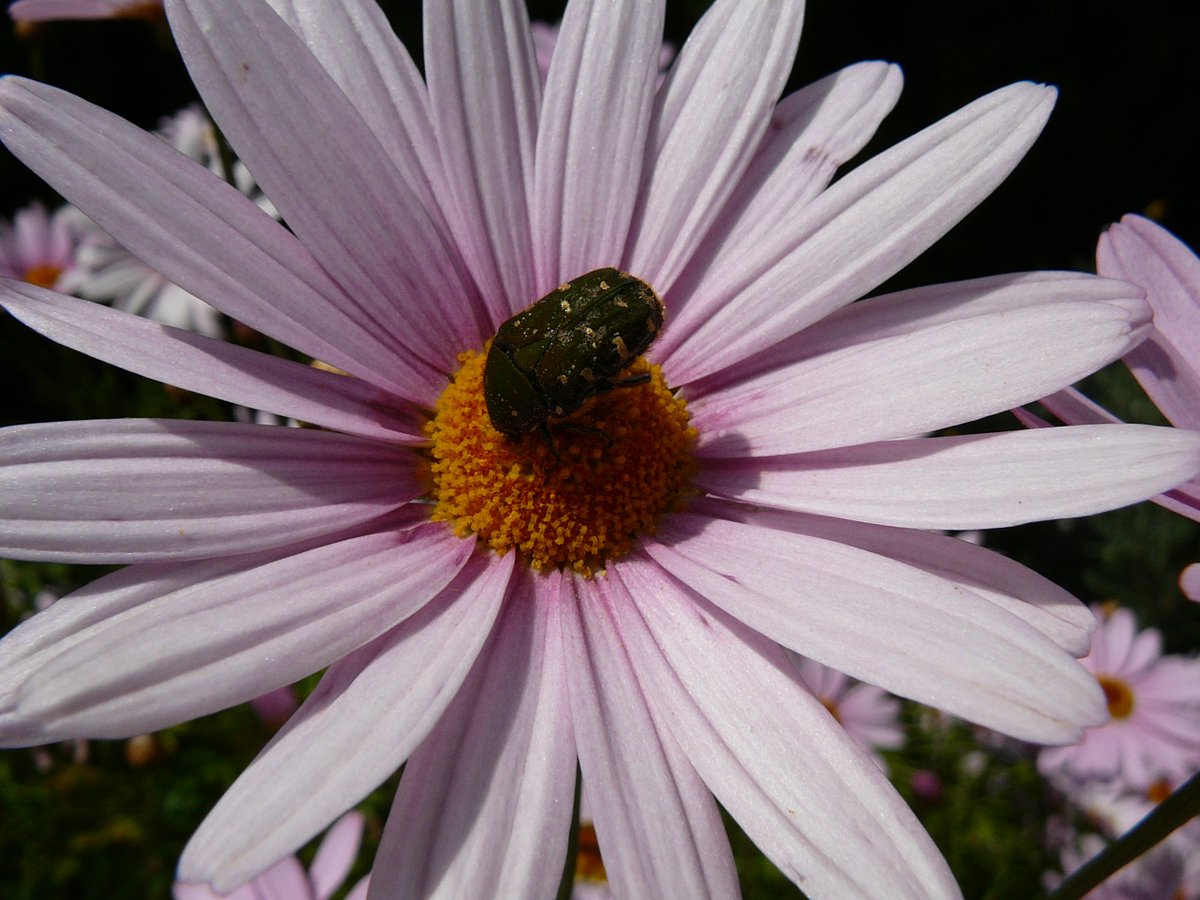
[426,347,696,576]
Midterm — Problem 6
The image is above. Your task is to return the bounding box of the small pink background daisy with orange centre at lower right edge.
[1038,610,1200,791]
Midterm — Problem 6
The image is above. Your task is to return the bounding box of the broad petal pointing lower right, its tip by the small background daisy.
[644,515,1104,743]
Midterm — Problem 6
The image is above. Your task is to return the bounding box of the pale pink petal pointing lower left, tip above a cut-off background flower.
[179,554,512,889]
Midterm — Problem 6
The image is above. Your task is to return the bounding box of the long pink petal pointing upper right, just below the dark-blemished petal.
[662,83,1055,384]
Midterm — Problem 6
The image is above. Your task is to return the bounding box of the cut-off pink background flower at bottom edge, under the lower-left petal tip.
[173,812,371,900]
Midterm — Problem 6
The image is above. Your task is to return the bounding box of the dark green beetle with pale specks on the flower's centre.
[484,269,662,448]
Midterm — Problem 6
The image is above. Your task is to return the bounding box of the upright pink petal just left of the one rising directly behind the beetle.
[425,0,541,326]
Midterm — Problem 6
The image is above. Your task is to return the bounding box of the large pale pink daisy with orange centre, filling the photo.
[0,0,1200,898]
